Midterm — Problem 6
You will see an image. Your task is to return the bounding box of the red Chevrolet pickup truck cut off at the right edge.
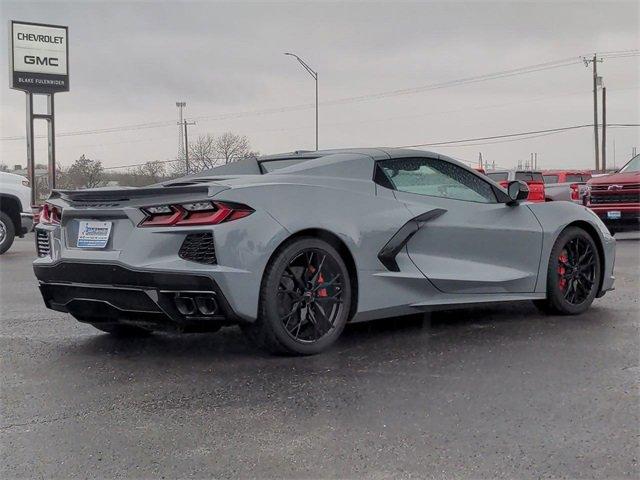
[586,154,640,234]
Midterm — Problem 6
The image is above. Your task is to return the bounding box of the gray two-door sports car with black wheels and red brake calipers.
[34,148,615,354]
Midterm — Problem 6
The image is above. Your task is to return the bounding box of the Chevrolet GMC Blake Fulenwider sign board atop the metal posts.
[9,20,69,93]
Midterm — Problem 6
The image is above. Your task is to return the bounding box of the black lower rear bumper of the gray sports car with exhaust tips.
[33,261,239,330]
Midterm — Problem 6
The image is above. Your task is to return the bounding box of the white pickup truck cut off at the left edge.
[0,172,33,255]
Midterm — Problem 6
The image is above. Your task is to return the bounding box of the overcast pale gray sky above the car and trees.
[0,0,640,168]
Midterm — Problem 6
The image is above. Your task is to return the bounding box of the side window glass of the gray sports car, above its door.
[379,158,497,203]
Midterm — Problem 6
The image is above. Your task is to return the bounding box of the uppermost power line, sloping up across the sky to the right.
[0,50,640,141]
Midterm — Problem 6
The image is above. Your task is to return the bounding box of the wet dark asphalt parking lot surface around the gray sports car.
[0,234,640,478]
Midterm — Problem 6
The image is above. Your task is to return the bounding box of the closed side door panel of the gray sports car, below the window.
[396,192,542,294]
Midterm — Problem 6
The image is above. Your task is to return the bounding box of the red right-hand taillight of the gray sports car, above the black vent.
[138,202,255,227]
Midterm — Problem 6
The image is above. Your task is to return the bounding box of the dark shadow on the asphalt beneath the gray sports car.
[62,302,598,363]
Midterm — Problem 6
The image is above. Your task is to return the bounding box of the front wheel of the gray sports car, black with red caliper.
[535,227,602,315]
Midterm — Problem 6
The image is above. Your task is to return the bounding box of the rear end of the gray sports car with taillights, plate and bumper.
[34,184,284,331]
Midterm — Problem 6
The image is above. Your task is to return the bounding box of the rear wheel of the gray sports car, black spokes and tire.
[241,237,351,355]
